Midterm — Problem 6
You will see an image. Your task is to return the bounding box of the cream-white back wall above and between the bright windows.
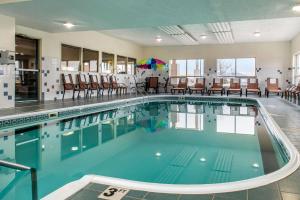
[144,42,291,90]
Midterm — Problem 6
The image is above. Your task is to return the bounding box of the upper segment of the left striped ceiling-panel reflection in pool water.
[171,147,198,167]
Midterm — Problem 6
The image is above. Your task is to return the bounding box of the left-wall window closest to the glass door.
[61,44,81,71]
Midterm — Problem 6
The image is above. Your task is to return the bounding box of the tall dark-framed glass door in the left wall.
[16,36,39,102]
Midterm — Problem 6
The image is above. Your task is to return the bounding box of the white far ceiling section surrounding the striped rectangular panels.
[101,17,300,46]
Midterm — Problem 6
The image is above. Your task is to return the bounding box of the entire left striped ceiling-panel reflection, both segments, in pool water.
[156,147,198,184]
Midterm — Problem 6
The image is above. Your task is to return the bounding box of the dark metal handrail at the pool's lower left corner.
[0,160,38,200]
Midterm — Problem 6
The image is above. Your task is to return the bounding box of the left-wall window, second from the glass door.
[82,49,99,72]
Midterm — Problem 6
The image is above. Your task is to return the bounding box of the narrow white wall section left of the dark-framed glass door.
[0,15,15,108]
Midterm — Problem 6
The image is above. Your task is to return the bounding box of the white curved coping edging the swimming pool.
[7,95,300,200]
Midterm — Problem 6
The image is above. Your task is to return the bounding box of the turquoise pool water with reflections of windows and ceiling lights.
[0,101,288,200]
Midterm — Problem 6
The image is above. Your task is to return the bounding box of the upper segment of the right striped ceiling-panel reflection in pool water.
[213,151,233,172]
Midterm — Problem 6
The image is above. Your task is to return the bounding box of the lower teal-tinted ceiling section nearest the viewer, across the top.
[0,0,300,32]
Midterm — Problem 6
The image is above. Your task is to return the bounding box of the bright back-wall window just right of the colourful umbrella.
[169,59,204,77]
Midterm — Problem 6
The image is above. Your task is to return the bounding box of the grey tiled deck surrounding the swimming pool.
[0,95,300,200]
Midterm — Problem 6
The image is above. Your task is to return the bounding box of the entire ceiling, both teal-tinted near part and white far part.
[0,0,300,46]
